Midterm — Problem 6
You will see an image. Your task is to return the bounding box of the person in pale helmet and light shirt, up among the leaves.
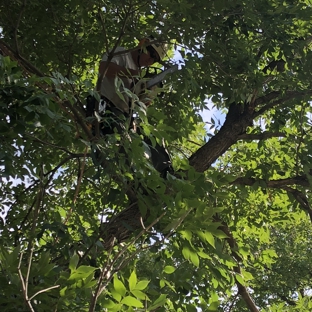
[87,36,173,178]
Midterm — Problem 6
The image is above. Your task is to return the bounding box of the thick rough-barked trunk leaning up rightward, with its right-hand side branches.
[100,92,309,247]
